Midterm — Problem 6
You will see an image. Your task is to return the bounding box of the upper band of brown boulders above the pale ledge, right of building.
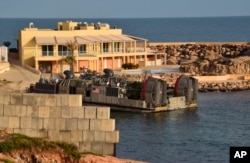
[149,42,250,75]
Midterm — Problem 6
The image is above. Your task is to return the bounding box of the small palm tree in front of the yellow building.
[65,41,78,72]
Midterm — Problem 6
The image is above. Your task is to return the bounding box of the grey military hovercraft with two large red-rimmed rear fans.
[29,69,198,112]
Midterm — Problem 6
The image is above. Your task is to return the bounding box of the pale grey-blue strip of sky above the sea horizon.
[0,0,250,18]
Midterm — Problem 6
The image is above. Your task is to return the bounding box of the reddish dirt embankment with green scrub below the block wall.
[0,130,145,163]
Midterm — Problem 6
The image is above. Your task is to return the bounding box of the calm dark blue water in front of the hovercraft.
[112,91,250,163]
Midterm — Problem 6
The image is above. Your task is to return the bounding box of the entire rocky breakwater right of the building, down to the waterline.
[146,42,250,91]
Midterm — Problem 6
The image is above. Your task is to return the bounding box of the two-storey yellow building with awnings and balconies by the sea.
[18,21,152,73]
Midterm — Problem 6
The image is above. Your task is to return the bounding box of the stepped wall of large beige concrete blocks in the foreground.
[0,93,119,155]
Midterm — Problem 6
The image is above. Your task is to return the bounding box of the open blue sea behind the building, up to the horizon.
[0,16,250,48]
